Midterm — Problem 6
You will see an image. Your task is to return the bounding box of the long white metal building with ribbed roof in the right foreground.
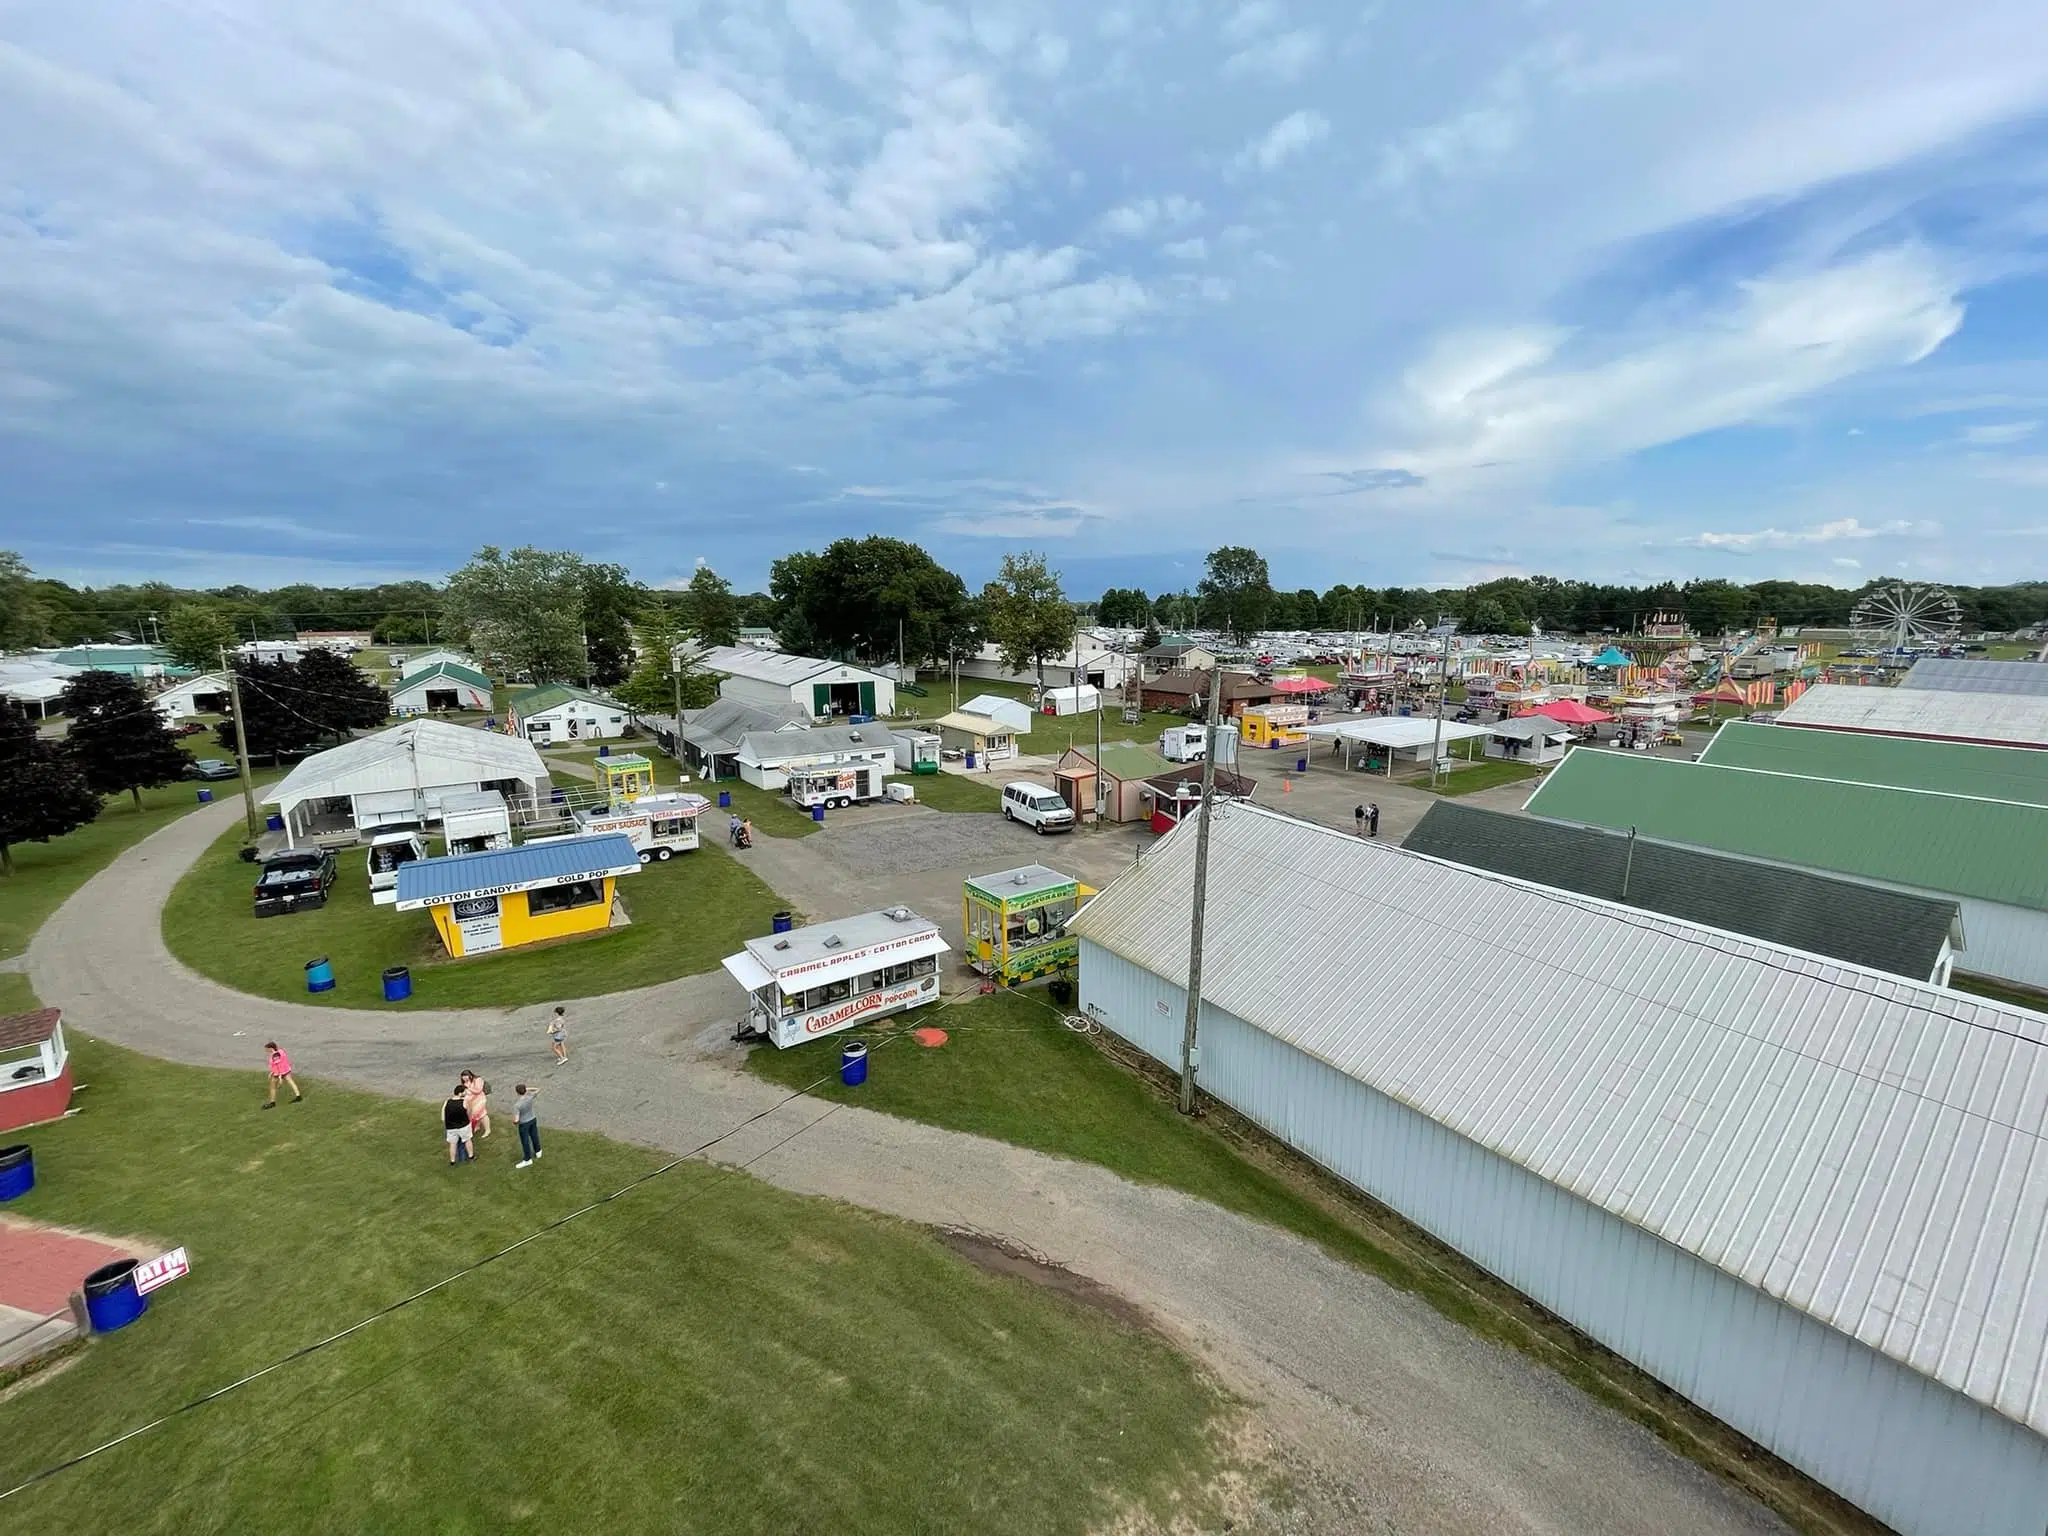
[1069,805,2048,1536]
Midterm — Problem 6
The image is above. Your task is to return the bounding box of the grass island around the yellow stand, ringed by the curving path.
[164,825,786,1008]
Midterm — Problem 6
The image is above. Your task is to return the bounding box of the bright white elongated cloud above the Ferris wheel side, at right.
[1372,246,1962,479]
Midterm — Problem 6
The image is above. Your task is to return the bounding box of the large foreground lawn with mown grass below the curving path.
[0,1040,1225,1536]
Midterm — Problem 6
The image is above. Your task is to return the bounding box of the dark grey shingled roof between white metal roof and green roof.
[1401,801,1956,981]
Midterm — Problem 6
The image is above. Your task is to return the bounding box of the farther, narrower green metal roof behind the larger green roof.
[1700,724,2048,805]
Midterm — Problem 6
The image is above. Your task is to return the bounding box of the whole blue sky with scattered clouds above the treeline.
[0,0,2048,592]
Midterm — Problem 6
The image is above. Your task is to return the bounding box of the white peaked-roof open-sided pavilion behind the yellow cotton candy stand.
[264,719,547,844]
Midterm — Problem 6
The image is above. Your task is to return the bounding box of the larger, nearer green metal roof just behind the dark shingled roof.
[1528,749,2048,911]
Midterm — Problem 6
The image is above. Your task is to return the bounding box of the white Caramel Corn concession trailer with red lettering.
[723,907,952,1049]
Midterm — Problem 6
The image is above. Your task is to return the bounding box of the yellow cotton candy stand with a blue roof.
[397,831,641,958]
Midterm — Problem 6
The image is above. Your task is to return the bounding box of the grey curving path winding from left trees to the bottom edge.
[29,805,1780,1534]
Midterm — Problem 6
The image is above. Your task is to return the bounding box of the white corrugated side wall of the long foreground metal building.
[1081,937,2048,1536]
